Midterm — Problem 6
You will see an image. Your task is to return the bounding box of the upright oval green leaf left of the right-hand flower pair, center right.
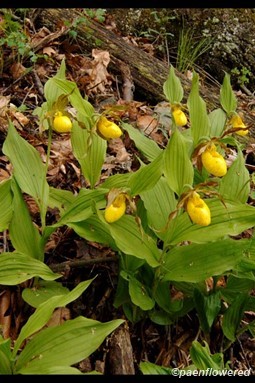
[164,129,194,196]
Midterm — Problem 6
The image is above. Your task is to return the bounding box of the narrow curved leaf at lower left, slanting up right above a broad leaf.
[13,277,95,356]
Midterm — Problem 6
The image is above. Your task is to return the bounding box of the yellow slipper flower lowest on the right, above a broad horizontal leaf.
[186,192,211,226]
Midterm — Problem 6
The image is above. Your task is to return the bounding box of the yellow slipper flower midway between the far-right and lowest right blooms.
[201,144,227,177]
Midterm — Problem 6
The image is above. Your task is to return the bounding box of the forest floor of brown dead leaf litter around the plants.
[0,7,255,375]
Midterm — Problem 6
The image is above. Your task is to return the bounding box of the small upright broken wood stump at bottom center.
[108,322,135,375]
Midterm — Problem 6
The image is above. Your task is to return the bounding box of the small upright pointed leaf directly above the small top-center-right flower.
[163,65,183,104]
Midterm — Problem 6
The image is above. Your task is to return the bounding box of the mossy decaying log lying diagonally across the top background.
[37,8,219,107]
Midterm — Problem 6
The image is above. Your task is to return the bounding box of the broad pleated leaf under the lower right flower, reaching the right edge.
[165,199,255,244]
